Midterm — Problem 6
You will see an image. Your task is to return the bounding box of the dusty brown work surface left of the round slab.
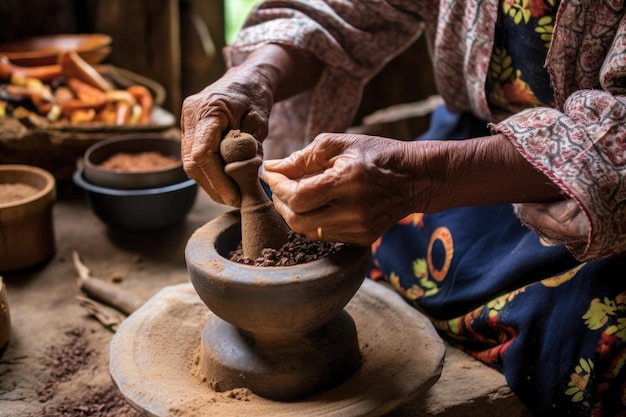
[0,186,232,417]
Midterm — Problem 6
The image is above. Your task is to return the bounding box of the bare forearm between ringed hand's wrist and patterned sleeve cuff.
[411,134,564,212]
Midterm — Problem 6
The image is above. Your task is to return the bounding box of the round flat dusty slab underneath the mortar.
[109,279,445,417]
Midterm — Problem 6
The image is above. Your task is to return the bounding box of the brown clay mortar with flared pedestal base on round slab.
[185,210,370,401]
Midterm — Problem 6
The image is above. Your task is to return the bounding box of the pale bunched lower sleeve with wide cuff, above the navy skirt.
[492,91,626,260]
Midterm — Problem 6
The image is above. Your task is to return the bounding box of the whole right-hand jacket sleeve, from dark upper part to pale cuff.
[494,3,626,260]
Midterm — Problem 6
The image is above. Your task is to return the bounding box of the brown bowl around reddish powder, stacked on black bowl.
[83,134,188,189]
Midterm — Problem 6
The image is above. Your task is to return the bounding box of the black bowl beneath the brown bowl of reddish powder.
[73,168,198,232]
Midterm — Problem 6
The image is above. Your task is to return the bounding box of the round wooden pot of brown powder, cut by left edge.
[0,165,56,274]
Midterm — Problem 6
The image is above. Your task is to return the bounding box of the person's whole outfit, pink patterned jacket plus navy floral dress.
[225,0,626,416]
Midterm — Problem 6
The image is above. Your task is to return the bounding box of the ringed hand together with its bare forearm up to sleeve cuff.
[262,133,563,246]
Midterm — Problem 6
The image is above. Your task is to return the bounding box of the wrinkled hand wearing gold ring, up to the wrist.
[262,134,424,246]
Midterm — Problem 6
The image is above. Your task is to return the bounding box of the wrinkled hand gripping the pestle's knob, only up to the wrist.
[181,65,273,207]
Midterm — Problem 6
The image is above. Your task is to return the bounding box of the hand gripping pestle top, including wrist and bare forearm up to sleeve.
[181,44,322,207]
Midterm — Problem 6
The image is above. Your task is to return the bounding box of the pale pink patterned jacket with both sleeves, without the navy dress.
[225,0,626,261]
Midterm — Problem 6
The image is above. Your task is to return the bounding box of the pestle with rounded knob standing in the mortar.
[220,130,289,259]
